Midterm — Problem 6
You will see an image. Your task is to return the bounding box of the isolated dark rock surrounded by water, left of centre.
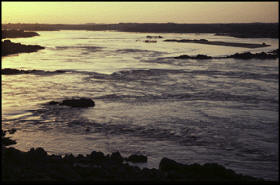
[49,98,95,108]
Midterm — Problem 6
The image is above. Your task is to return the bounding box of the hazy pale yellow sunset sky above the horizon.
[1,1,279,24]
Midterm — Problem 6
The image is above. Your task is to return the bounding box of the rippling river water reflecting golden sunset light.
[2,31,279,180]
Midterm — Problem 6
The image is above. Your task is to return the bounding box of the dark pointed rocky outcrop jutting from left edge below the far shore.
[1,40,44,56]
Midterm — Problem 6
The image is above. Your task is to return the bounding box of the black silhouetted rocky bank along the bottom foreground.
[1,131,268,184]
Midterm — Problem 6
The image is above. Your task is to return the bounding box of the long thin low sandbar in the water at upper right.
[164,39,269,48]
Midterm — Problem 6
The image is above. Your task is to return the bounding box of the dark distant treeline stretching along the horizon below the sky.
[2,23,278,38]
